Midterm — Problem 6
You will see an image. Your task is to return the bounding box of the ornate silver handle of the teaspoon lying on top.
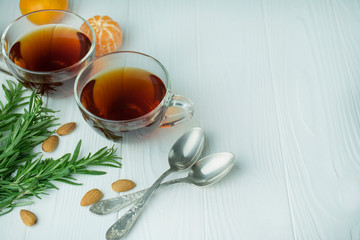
[106,168,173,239]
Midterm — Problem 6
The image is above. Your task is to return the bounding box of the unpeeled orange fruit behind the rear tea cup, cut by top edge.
[19,0,69,25]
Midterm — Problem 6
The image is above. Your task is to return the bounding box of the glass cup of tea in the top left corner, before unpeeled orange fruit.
[0,10,95,97]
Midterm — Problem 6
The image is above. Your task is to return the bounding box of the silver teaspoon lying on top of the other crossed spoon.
[106,127,205,239]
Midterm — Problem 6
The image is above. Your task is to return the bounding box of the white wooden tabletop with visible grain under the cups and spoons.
[0,0,360,240]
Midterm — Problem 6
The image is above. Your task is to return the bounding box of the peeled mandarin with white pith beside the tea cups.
[80,15,122,57]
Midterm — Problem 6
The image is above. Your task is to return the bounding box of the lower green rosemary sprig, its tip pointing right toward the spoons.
[0,140,121,216]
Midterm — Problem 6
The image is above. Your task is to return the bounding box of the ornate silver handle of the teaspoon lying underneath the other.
[90,177,187,215]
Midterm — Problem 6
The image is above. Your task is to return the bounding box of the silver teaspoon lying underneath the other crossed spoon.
[90,152,235,215]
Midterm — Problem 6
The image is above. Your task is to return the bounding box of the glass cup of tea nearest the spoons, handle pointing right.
[74,51,194,141]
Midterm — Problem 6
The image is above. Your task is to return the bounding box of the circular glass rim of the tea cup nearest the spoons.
[74,51,173,124]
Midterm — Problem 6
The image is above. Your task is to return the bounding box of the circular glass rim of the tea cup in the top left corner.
[0,9,96,76]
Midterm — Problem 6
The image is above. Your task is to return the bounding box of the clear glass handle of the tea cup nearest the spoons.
[160,95,194,128]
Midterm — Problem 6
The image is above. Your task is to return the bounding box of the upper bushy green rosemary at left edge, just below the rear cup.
[0,81,58,180]
